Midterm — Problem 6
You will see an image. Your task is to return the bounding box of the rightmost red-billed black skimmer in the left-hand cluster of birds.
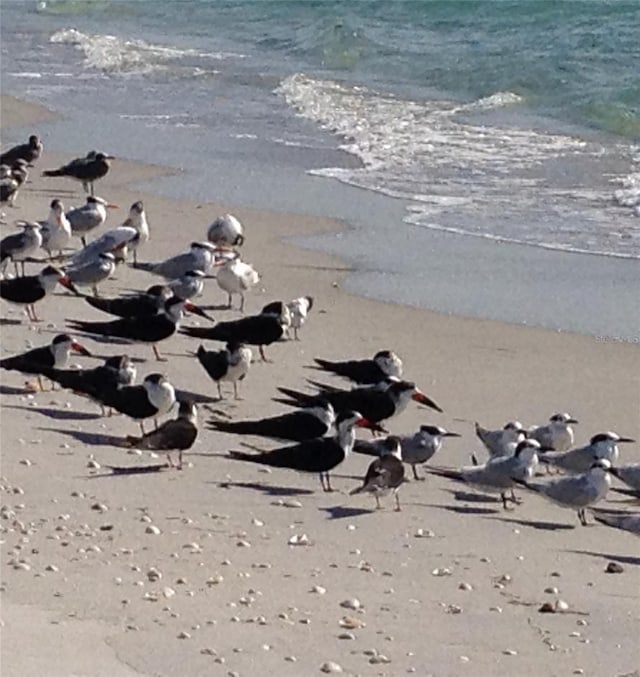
[68,296,212,361]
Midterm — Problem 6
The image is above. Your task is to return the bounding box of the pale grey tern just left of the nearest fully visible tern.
[427,440,540,510]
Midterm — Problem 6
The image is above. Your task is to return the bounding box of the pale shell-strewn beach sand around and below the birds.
[0,99,640,677]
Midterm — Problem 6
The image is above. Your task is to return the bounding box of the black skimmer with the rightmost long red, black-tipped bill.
[275,381,442,423]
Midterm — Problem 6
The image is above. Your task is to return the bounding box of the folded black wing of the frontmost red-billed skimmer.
[229,438,344,473]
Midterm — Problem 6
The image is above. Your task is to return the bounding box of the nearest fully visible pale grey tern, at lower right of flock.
[516,458,611,526]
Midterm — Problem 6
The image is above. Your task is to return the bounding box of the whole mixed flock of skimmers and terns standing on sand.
[0,135,640,535]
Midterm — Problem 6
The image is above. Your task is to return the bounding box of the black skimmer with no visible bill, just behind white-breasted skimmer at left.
[37,355,136,413]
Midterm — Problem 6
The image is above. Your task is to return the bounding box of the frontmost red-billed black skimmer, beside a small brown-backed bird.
[229,411,369,491]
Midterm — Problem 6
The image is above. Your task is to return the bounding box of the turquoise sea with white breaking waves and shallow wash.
[1,0,640,331]
